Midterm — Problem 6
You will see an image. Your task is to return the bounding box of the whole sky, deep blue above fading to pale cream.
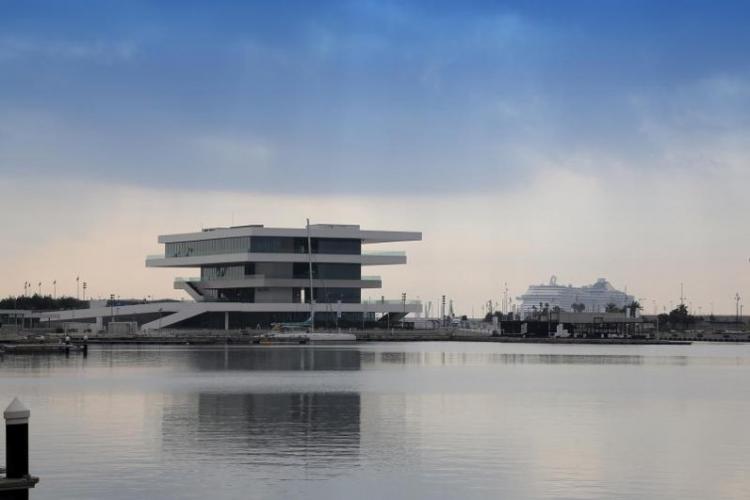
[0,0,750,314]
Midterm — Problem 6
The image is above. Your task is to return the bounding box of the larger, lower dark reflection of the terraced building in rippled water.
[162,392,361,478]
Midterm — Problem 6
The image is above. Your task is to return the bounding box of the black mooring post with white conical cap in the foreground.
[0,398,39,500]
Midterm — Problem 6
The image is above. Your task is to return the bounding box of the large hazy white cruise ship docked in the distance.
[517,276,634,316]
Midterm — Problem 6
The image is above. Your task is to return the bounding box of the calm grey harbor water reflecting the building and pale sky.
[0,343,750,500]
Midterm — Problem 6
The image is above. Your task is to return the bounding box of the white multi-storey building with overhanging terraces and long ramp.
[33,224,422,330]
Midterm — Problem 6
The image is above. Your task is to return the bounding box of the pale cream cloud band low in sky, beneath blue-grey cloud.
[0,166,750,313]
